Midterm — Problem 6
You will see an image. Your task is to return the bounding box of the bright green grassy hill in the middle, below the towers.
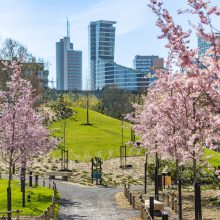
[50,108,144,161]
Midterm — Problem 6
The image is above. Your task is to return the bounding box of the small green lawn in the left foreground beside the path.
[0,179,53,216]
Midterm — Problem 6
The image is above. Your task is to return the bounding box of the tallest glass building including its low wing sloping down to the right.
[89,20,163,91]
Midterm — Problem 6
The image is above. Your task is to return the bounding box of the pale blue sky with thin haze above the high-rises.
[0,0,220,87]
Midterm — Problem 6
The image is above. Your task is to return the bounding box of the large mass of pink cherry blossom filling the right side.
[129,0,220,180]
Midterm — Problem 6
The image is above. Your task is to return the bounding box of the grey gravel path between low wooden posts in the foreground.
[53,181,139,220]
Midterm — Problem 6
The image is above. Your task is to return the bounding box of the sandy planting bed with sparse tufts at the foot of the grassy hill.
[0,156,148,186]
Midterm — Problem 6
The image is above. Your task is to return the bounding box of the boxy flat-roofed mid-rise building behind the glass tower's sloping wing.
[133,55,164,87]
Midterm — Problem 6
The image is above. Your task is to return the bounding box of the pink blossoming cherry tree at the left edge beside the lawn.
[0,62,56,210]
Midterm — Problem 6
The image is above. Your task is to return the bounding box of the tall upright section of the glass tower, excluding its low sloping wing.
[88,20,116,90]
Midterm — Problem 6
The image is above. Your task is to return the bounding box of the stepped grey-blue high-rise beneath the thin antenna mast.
[56,35,82,90]
